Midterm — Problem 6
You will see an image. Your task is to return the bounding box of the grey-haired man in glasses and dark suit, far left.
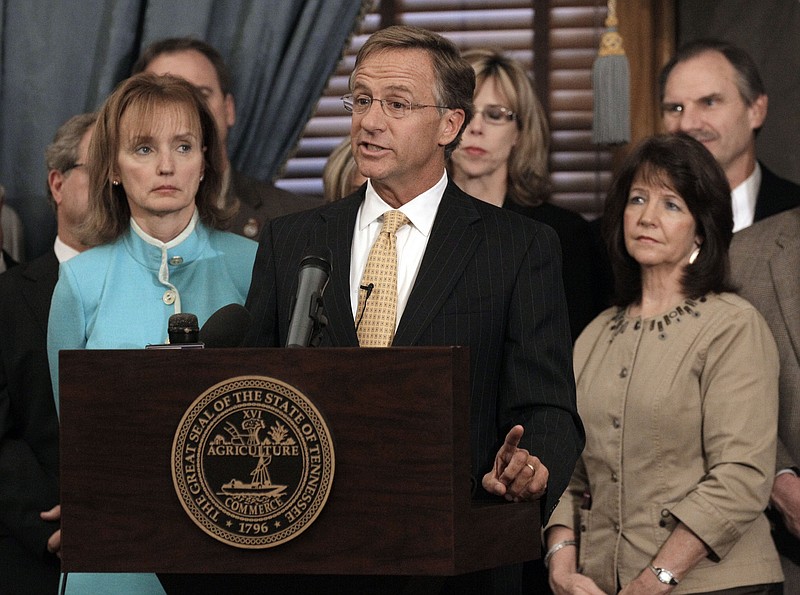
[0,114,97,595]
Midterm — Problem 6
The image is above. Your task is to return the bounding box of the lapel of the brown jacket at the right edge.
[769,224,800,360]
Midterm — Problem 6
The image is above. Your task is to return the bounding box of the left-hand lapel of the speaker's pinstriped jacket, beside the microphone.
[316,196,364,347]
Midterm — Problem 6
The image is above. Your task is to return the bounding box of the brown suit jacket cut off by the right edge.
[730,208,800,469]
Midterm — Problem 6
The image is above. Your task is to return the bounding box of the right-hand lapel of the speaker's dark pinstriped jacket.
[392,182,481,345]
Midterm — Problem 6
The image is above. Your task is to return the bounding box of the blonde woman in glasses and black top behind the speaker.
[450,49,605,340]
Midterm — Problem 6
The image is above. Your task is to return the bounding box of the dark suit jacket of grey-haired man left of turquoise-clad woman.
[0,250,59,593]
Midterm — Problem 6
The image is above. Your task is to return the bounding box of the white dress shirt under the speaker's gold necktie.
[350,172,447,329]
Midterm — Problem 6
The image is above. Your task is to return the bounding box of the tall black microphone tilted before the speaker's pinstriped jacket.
[286,246,331,347]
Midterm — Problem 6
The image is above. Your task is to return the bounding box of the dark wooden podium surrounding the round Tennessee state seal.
[60,347,540,576]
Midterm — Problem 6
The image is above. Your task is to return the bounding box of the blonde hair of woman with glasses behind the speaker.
[463,49,550,206]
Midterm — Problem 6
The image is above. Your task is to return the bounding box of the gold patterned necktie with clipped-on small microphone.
[356,211,408,347]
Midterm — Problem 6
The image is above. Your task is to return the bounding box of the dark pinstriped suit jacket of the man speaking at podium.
[245,182,584,518]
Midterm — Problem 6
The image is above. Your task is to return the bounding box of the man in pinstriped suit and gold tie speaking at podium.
[245,26,584,593]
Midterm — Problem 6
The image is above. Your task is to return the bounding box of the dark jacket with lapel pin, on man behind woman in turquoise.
[229,171,322,240]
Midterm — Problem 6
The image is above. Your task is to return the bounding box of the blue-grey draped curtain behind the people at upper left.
[0,0,362,259]
